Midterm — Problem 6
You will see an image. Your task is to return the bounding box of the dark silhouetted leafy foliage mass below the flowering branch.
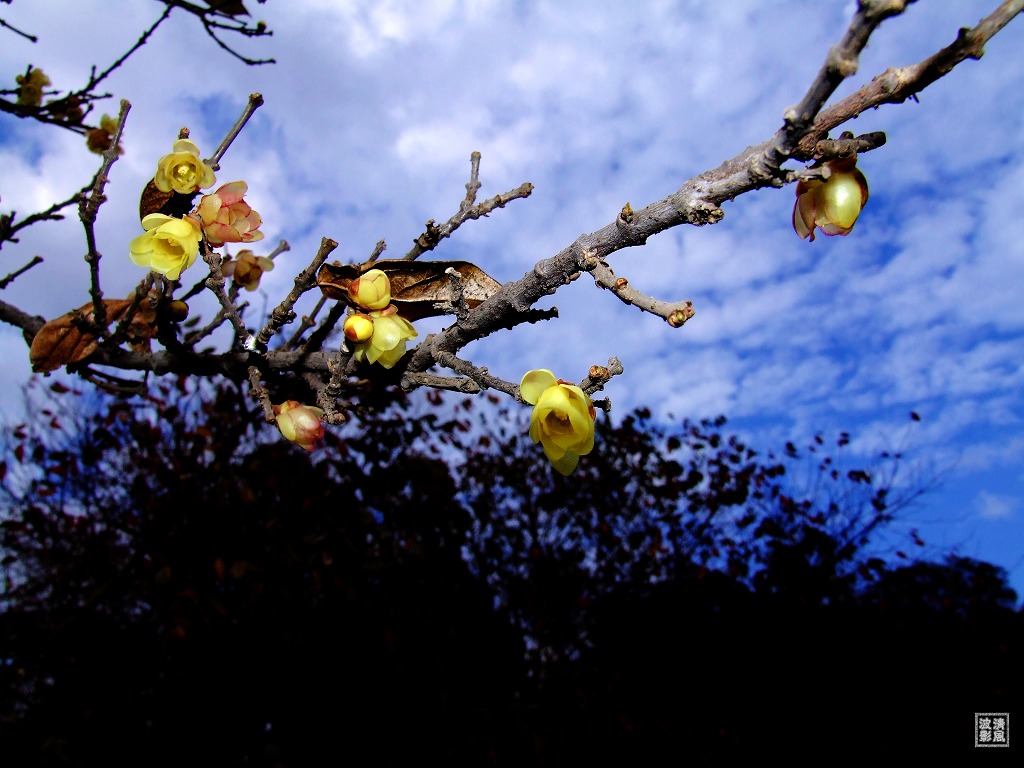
[0,380,1022,766]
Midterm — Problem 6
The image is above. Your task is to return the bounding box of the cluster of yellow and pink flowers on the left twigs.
[128,138,272,282]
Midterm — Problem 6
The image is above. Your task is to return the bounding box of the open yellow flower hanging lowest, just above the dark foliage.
[519,370,596,475]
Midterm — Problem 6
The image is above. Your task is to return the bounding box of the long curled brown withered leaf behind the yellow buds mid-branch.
[316,259,502,321]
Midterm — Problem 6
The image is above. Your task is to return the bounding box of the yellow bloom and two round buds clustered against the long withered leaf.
[344,269,418,368]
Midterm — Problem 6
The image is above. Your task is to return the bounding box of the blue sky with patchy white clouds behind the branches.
[0,0,1024,593]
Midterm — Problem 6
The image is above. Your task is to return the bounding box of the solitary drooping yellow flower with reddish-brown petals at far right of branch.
[793,158,867,242]
